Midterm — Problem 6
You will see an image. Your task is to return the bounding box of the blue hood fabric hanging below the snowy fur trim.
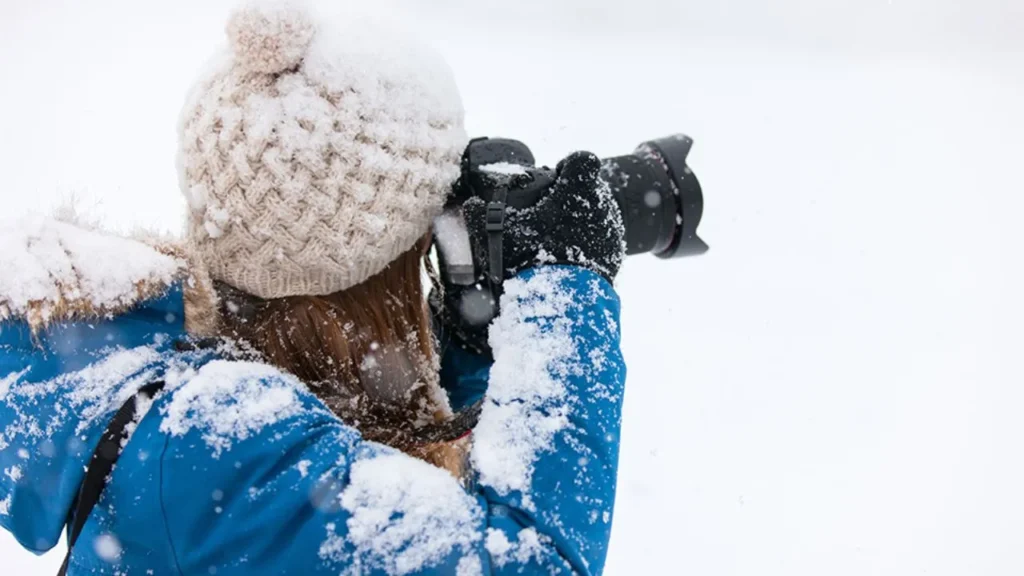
[0,286,190,553]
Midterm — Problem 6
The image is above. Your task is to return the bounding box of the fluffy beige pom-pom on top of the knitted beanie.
[227,0,316,74]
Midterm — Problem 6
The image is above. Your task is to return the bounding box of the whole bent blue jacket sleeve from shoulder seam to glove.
[151,268,625,575]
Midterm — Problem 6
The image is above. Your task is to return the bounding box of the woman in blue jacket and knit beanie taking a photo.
[0,2,625,575]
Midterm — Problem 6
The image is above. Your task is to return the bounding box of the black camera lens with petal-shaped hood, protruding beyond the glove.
[601,134,708,258]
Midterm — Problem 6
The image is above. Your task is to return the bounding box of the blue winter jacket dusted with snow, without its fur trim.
[0,223,625,576]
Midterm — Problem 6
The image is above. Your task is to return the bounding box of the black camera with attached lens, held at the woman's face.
[434,134,708,331]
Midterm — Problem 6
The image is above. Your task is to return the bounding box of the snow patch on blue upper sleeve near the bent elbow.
[321,453,483,575]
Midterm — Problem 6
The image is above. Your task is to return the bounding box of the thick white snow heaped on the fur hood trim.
[0,216,184,328]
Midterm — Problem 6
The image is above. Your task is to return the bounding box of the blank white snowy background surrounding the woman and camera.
[0,0,1024,576]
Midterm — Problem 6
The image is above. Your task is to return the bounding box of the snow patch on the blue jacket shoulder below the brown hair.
[160,360,303,458]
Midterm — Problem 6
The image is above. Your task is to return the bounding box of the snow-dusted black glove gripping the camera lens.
[463,152,626,282]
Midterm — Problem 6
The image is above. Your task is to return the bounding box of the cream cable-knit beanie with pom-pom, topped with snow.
[178,0,468,298]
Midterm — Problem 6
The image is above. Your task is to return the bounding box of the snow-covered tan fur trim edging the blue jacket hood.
[0,216,217,336]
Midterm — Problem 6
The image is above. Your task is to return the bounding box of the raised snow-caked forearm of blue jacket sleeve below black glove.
[472,266,626,574]
